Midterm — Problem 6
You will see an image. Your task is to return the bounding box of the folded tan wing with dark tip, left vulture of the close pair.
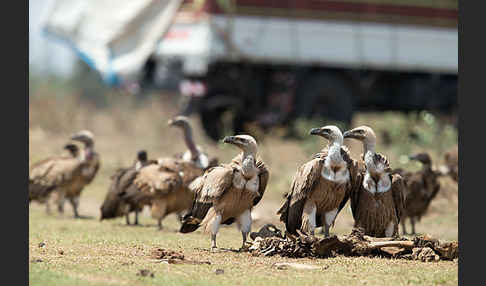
[277,156,324,234]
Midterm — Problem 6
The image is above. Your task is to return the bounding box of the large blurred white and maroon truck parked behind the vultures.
[41,0,458,140]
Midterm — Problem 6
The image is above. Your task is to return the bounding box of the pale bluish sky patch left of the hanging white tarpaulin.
[29,0,76,77]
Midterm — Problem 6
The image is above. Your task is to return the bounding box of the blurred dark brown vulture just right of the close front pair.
[398,153,442,234]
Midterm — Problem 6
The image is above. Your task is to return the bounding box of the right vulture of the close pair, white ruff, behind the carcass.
[343,126,405,237]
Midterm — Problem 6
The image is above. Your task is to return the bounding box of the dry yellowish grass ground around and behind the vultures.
[29,92,458,285]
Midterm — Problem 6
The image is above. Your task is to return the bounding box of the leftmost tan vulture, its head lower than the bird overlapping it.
[29,144,85,213]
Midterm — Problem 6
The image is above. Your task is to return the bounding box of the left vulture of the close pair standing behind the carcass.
[277,125,358,237]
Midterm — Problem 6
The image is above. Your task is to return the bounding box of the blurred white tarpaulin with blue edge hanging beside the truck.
[43,0,182,85]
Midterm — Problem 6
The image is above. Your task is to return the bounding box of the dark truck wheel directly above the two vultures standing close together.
[297,73,353,126]
